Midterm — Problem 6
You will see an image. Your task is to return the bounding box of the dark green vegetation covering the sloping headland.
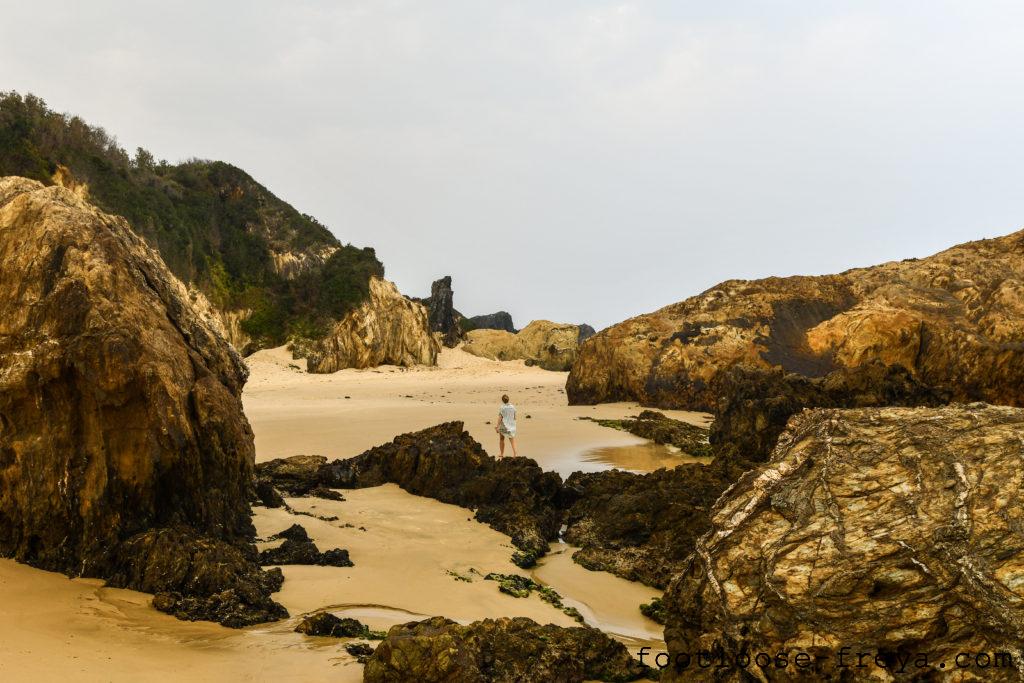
[0,92,384,350]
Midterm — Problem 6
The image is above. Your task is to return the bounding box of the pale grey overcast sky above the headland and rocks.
[0,0,1024,328]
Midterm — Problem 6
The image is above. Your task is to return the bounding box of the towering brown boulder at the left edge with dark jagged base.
[0,177,285,626]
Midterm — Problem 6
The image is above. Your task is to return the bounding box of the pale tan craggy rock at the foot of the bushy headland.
[306,278,439,373]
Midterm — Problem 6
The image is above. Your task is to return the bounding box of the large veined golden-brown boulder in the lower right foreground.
[663,403,1024,681]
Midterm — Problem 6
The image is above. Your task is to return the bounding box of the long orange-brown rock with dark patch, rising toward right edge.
[566,231,1024,411]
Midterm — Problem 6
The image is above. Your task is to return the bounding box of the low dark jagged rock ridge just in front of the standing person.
[257,422,562,556]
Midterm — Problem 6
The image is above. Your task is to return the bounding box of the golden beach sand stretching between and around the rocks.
[0,349,707,681]
